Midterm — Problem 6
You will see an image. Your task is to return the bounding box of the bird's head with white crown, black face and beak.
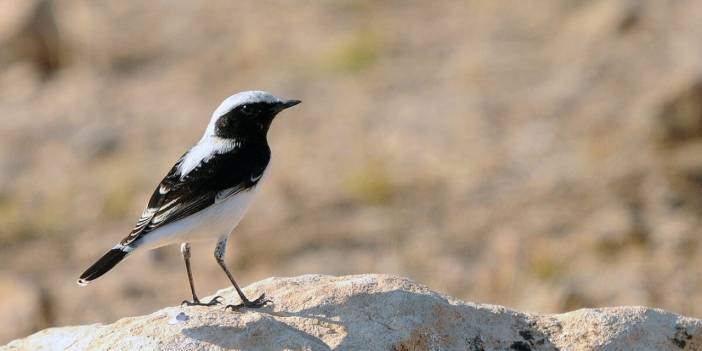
[205,91,300,140]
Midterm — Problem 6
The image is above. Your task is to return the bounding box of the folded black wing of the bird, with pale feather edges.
[120,145,271,246]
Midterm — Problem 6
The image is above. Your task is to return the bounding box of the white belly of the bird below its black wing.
[139,181,261,249]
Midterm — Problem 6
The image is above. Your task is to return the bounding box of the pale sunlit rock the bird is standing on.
[3,274,702,351]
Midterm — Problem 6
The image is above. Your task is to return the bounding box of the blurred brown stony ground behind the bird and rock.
[0,0,702,342]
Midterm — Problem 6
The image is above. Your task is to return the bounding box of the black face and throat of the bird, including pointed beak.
[215,100,299,141]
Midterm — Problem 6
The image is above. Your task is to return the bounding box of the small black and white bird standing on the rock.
[78,91,301,310]
